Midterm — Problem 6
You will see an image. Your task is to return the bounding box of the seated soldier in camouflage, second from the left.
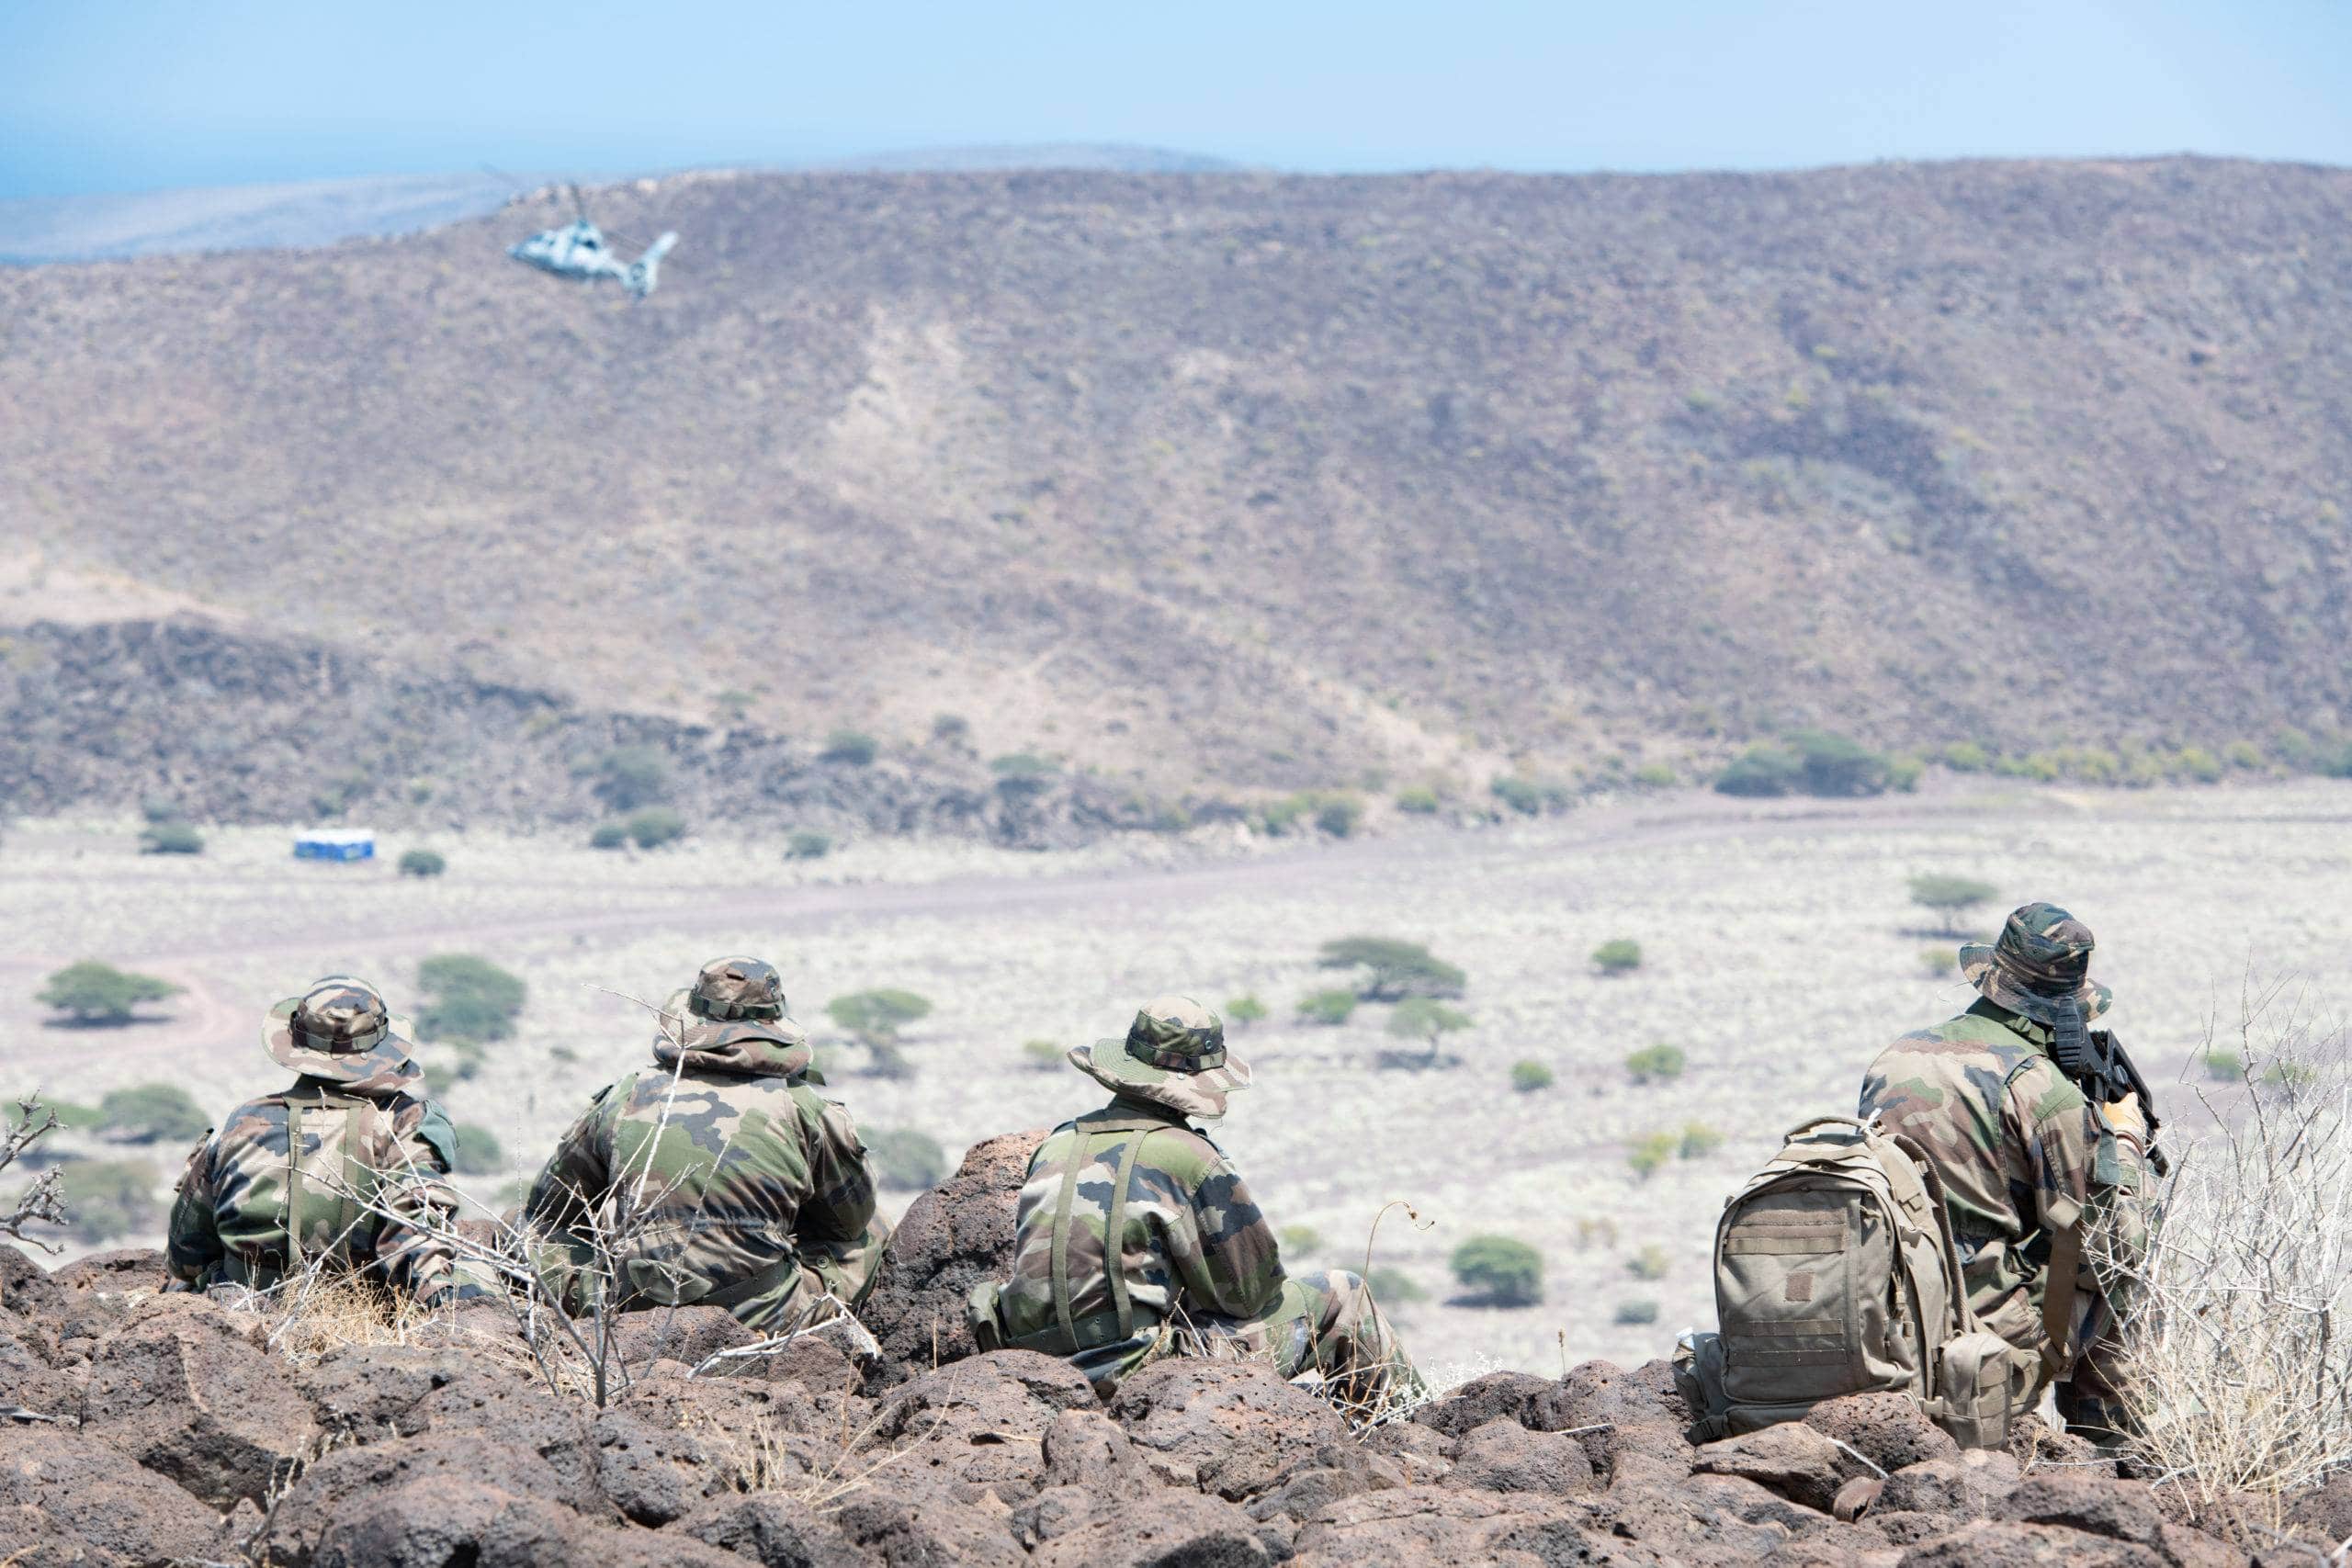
[522,957,889,1331]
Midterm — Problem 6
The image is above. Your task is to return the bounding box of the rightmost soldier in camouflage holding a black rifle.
[1860,903,2147,1432]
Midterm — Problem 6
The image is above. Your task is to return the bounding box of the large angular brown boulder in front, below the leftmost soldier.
[83,1295,320,1512]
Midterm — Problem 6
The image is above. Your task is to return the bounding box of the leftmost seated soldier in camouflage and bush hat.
[167,976,484,1304]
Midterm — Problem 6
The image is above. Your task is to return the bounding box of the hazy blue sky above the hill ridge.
[0,0,2352,197]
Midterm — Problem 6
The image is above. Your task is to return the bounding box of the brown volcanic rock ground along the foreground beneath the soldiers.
[0,1134,2352,1568]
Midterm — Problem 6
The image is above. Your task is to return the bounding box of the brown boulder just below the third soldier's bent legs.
[1110,1357,1352,1502]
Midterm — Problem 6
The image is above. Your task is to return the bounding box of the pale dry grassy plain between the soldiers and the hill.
[0,781,2352,1382]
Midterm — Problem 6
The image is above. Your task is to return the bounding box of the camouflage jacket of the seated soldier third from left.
[997,1096,1284,1384]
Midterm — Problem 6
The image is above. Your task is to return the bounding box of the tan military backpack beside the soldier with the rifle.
[1675,1117,2032,1448]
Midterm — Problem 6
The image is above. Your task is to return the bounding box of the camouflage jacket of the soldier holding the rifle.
[1860,1001,2124,1349]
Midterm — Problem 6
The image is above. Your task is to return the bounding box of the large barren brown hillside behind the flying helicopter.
[0,160,2352,822]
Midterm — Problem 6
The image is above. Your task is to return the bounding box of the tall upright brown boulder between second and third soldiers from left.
[858,1128,1046,1387]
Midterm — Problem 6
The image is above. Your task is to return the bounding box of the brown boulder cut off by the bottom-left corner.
[0,1425,235,1563]
